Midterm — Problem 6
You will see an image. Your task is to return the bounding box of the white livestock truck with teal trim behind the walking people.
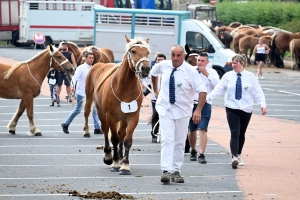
[94,6,235,76]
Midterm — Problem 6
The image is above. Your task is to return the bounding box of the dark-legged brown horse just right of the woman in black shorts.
[271,32,300,68]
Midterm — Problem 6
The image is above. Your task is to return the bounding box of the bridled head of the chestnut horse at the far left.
[47,44,73,73]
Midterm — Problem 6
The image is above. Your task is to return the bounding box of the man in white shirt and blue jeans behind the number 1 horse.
[61,52,102,137]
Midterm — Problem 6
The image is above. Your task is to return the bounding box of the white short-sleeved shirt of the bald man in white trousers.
[150,60,206,119]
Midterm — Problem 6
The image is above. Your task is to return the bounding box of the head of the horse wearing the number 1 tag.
[125,35,150,79]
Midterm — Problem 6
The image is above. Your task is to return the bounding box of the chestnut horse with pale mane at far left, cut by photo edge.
[0,45,73,136]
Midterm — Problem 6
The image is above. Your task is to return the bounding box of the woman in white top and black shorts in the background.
[254,38,270,79]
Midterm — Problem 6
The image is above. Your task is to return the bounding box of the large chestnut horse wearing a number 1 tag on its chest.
[83,36,150,175]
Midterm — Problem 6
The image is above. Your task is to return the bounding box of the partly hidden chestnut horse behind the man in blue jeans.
[67,41,114,66]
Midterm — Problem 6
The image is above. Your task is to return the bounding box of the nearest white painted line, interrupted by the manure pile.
[0,190,243,199]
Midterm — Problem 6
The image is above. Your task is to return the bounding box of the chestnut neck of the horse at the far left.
[28,51,54,85]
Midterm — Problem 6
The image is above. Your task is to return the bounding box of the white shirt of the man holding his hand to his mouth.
[194,65,220,105]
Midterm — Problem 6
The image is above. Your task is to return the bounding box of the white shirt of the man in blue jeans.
[72,63,92,96]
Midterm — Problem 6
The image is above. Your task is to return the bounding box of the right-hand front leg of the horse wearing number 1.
[120,118,138,175]
